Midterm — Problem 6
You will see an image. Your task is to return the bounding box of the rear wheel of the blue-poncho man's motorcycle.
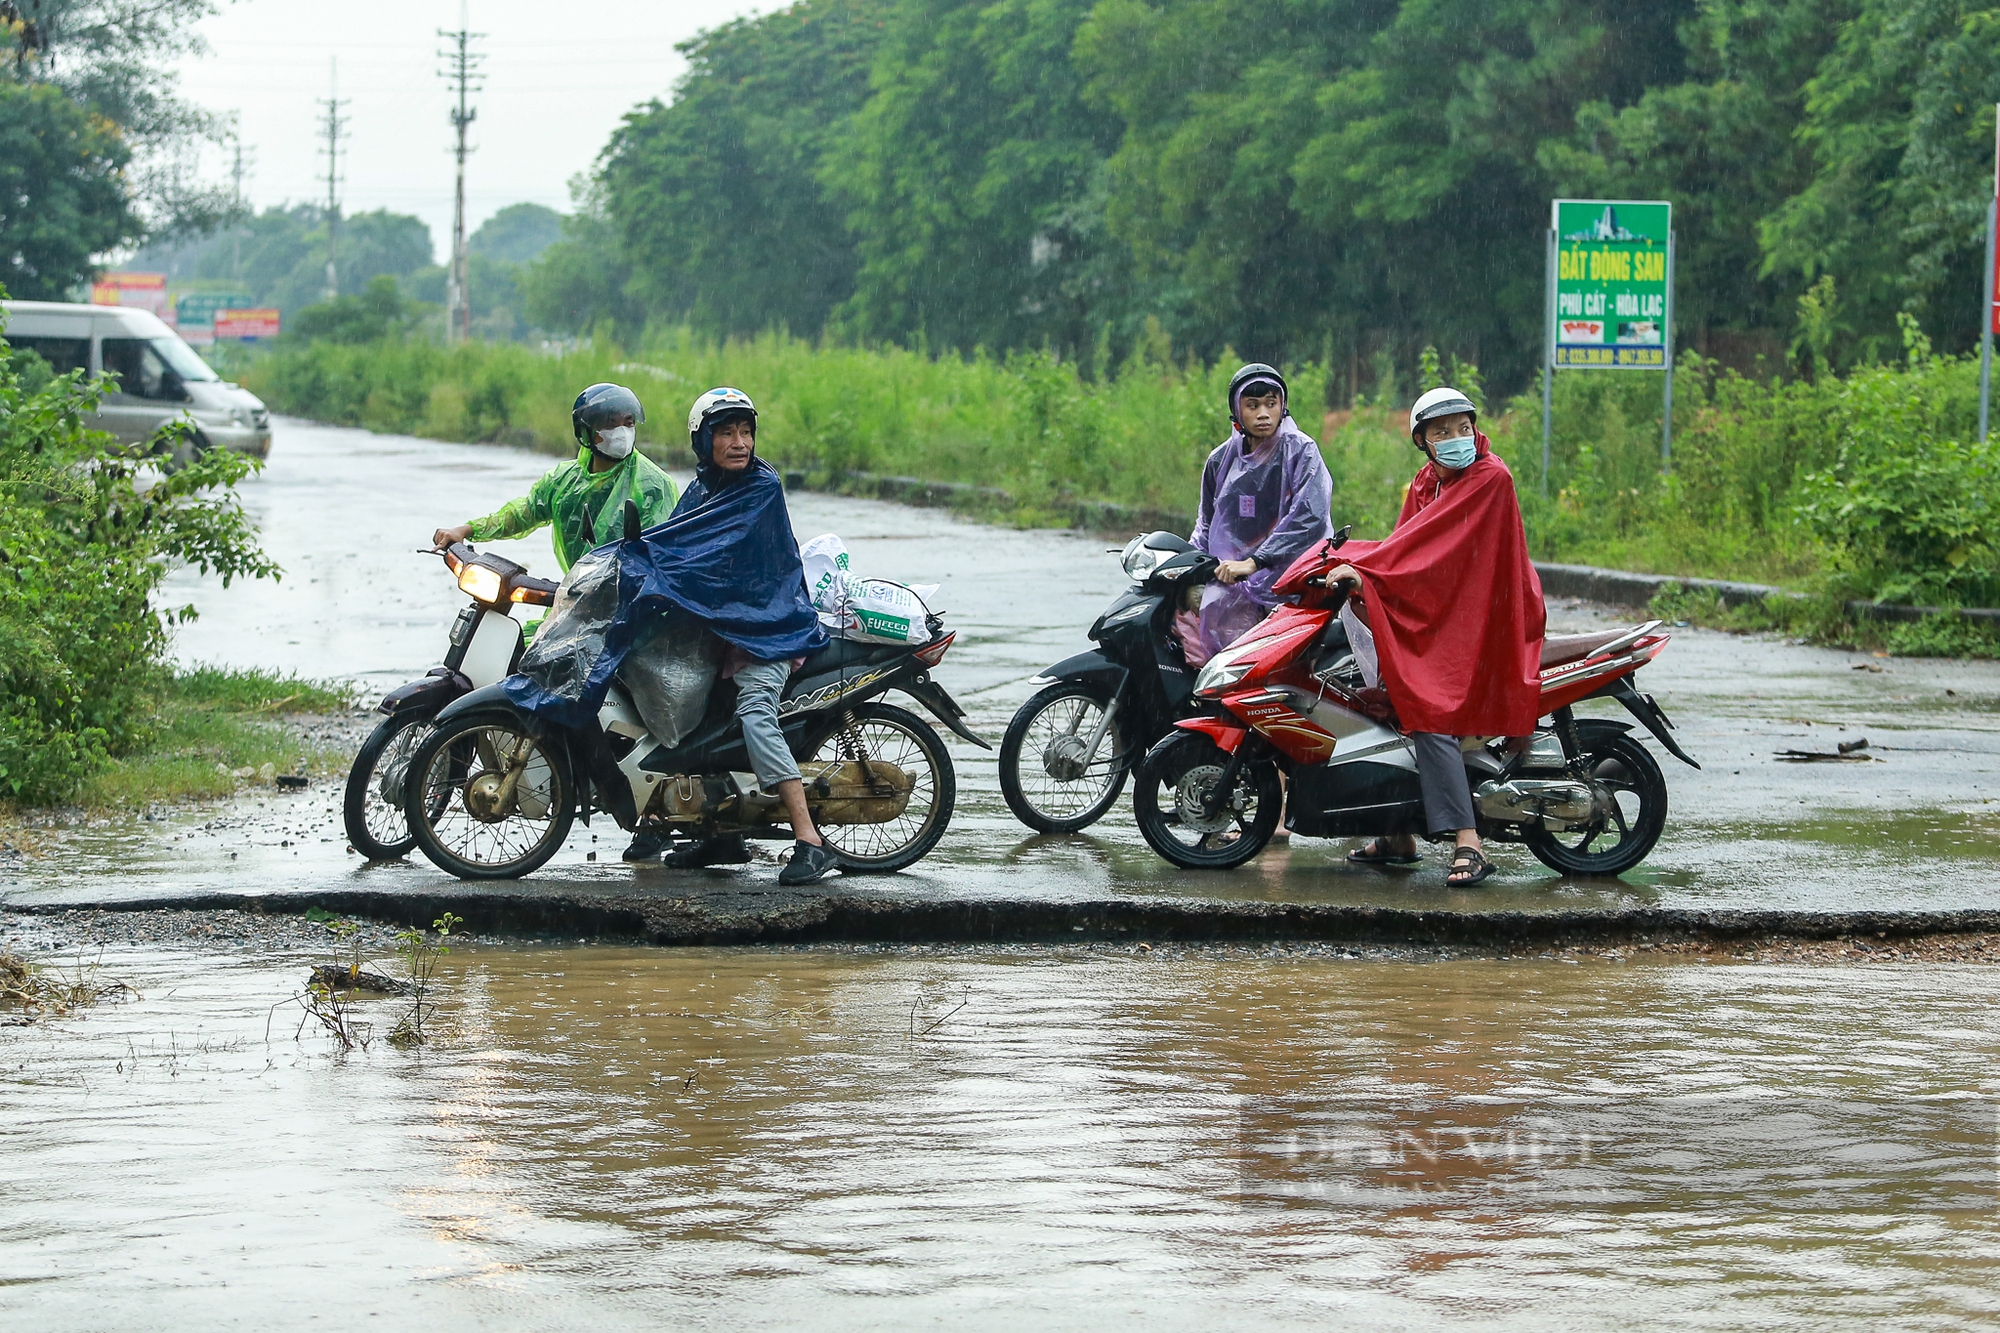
[812,703,958,875]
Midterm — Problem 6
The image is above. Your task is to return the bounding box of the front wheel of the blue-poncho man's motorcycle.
[402,713,576,879]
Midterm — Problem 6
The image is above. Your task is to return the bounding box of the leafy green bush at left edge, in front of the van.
[0,300,278,805]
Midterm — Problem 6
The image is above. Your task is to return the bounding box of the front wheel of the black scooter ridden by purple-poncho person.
[1000,681,1126,833]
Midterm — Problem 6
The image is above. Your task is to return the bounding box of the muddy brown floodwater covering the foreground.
[0,945,2000,1329]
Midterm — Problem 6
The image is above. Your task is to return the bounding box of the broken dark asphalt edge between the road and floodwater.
[15,889,2000,949]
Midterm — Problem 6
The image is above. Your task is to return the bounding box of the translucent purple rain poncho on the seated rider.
[1184,412,1334,664]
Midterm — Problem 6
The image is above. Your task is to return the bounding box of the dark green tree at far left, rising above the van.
[0,78,144,300]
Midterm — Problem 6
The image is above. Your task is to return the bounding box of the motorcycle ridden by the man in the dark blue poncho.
[404,502,992,879]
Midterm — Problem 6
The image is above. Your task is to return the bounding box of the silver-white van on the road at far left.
[0,300,270,458]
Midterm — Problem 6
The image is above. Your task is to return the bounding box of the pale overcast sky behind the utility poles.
[180,0,776,260]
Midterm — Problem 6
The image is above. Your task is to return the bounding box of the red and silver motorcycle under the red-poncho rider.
[1132,530,1700,875]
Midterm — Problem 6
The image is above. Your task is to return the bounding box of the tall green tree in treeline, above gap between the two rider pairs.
[824,0,1122,350]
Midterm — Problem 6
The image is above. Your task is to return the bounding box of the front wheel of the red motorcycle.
[1132,731,1284,871]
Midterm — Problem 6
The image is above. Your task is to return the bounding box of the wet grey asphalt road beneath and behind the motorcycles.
[0,420,2000,911]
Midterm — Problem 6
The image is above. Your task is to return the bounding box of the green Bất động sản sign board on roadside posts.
[1554,198,1674,370]
